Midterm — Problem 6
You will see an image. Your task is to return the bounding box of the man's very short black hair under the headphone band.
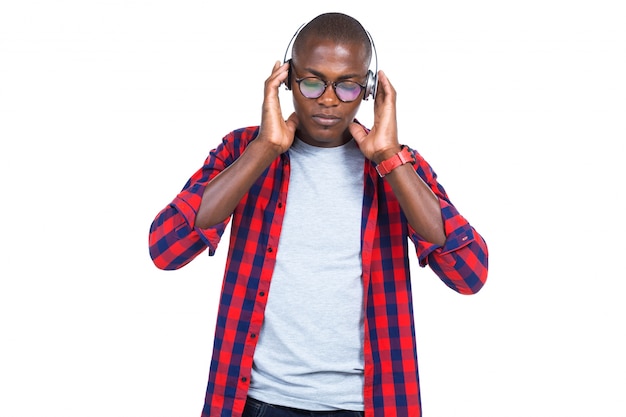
[292,12,372,62]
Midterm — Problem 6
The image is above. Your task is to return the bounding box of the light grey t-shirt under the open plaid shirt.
[249,138,365,410]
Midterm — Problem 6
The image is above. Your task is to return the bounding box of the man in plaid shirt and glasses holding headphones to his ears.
[150,13,488,417]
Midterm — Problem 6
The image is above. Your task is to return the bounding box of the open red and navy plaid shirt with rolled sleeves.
[149,127,488,417]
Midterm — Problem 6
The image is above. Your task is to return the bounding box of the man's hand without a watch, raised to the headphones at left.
[256,61,298,154]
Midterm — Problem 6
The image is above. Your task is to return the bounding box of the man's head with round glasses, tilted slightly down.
[288,13,372,146]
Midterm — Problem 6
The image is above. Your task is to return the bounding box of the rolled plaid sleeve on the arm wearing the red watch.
[409,150,489,294]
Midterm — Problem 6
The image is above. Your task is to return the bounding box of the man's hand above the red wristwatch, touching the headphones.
[350,71,400,164]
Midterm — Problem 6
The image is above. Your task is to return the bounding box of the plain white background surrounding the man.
[0,0,626,417]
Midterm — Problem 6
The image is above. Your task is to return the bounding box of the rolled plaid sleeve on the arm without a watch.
[148,128,256,270]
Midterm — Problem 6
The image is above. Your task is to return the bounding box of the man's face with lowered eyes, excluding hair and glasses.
[291,39,368,147]
